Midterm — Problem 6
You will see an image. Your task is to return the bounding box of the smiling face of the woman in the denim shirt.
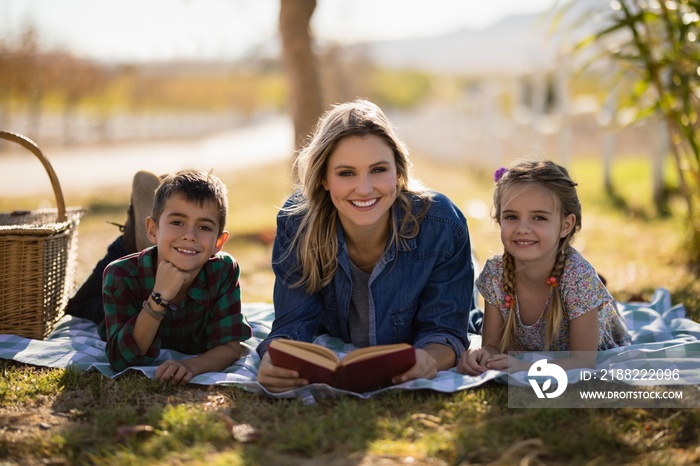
[321,135,398,231]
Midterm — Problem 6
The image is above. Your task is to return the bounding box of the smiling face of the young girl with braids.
[499,184,576,267]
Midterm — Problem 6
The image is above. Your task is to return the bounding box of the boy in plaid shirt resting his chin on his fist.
[68,170,252,384]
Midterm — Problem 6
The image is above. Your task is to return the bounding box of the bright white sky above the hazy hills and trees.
[0,0,557,61]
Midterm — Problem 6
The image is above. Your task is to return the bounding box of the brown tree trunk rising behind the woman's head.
[279,0,323,149]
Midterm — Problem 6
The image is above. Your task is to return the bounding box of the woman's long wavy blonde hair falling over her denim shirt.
[286,99,432,293]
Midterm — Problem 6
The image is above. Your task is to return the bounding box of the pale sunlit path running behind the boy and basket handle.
[0,117,294,197]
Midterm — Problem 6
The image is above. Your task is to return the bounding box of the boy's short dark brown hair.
[151,170,228,236]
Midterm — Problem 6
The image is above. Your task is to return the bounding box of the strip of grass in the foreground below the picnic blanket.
[0,364,700,466]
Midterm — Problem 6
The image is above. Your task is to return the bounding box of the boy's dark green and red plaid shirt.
[98,247,252,371]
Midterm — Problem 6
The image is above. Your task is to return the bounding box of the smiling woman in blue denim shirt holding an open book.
[258,100,474,392]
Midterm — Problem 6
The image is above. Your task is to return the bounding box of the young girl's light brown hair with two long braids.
[493,160,581,352]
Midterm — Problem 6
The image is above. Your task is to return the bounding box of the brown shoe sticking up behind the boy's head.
[123,171,160,253]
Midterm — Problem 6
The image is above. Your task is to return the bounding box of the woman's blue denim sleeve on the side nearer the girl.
[414,220,474,363]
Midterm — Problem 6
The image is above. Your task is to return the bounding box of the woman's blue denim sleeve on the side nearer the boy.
[257,211,322,357]
